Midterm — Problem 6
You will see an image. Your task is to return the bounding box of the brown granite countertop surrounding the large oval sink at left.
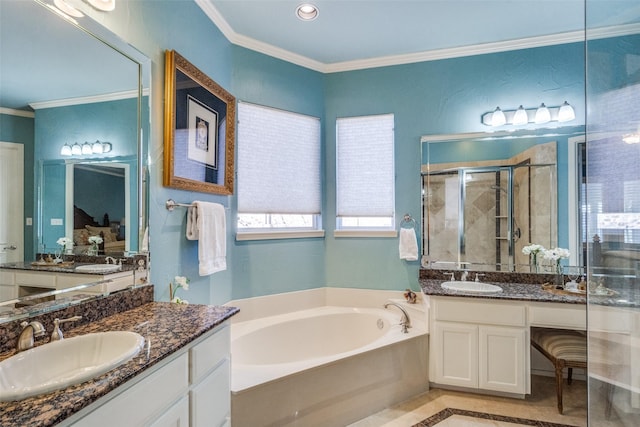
[0,302,239,427]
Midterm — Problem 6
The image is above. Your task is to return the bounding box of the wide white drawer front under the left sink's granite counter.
[74,354,189,427]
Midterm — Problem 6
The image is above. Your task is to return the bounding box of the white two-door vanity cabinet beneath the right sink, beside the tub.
[429,296,531,395]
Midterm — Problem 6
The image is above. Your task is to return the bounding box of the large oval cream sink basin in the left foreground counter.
[0,331,144,402]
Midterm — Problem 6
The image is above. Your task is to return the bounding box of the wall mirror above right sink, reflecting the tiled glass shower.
[421,127,584,272]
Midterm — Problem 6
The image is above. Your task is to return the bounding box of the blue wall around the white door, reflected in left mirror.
[0,113,35,261]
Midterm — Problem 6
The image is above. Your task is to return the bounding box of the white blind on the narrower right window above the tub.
[336,114,395,217]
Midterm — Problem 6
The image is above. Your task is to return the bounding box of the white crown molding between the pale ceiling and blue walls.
[195,0,640,73]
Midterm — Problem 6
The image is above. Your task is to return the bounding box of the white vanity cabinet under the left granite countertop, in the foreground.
[63,322,231,427]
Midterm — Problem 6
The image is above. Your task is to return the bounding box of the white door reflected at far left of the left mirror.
[0,142,24,263]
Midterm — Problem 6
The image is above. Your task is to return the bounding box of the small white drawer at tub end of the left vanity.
[189,324,231,384]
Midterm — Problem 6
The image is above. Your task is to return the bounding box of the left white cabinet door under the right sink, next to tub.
[429,322,478,388]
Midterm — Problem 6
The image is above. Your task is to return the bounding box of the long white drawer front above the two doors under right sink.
[433,298,526,326]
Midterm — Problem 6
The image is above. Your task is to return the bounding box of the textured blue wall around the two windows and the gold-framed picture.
[89,0,584,304]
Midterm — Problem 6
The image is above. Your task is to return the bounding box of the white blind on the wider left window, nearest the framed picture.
[238,102,321,214]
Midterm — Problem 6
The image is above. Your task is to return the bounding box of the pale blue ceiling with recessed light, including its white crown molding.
[200,0,640,72]
